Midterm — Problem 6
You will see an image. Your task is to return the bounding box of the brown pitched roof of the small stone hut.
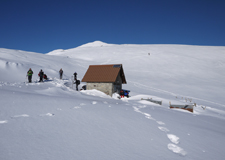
[82,64,127,84]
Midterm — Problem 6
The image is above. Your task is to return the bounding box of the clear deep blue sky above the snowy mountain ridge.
[0,0,225,53]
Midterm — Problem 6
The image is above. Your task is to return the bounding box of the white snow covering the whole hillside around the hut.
[0,41,225,160]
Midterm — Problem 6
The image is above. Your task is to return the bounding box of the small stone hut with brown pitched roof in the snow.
[82,64,127,96]
